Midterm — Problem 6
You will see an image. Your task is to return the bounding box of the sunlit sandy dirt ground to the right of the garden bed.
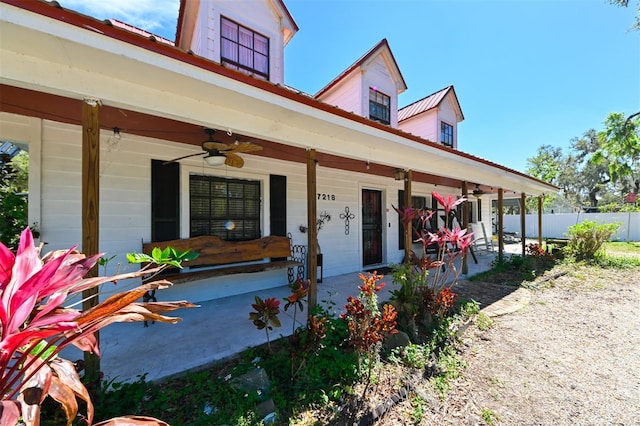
[378,266,640,425]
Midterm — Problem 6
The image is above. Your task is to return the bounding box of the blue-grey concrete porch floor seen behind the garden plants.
[81,244,521,382]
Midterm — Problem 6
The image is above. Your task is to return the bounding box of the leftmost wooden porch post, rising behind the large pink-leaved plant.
[82,98,100,383]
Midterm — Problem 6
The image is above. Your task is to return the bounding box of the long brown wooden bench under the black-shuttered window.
[142,236,304,284]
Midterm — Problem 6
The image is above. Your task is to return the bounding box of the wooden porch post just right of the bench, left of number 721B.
[307,149,318,312]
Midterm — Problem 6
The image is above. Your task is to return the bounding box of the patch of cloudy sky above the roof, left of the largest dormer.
[59,0,180,40]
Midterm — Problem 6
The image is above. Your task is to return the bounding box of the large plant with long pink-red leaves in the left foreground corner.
[0,228,194,426]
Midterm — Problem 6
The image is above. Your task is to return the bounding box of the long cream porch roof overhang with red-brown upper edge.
[0,1,557,195]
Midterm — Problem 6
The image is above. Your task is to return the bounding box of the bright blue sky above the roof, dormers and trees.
[60,0,640,171]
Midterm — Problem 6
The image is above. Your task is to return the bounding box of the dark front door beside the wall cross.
[362,189,382,266]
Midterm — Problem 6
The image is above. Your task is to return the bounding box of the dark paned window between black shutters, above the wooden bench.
[189,175,261,241]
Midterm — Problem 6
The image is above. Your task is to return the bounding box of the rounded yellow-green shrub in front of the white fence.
[566,220,620,260]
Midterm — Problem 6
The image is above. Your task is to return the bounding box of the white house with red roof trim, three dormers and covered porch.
[0,0,557,302]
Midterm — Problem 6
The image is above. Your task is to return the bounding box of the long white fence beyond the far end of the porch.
[504,212,640,241]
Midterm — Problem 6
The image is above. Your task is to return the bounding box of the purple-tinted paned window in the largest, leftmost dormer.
[220,18,269,80]
